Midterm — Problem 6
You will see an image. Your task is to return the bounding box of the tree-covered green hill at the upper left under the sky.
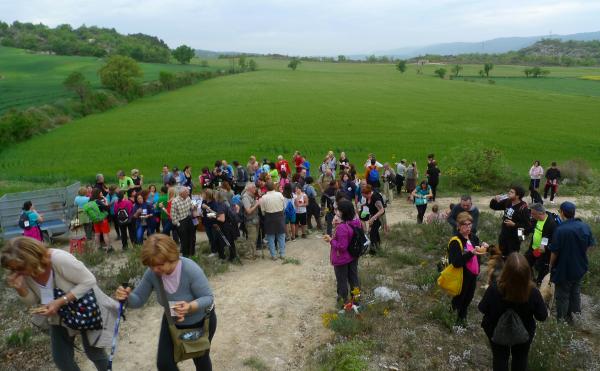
[0,21,171,63]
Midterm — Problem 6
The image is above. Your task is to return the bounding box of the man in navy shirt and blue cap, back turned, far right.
[549,201,596,322]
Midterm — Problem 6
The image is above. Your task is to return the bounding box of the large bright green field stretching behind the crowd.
[0,55,600,190]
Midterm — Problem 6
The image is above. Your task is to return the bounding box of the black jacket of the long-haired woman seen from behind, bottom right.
[478,284,548,338]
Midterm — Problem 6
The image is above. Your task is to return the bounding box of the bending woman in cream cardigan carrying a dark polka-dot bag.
[0,237,118,371]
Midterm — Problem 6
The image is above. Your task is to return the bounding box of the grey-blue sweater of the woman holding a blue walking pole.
[127,257,214,325]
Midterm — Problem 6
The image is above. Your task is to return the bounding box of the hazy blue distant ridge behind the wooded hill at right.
[374,31,600,58]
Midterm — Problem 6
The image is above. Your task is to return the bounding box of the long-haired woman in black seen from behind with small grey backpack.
[479,253,548,371]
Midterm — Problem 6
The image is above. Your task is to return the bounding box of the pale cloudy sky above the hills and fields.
[0,0,600,56]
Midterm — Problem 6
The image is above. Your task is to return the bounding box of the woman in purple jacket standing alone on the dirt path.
[323,199,362,307]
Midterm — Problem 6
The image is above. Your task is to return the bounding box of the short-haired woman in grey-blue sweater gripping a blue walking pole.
[115,234,217,371]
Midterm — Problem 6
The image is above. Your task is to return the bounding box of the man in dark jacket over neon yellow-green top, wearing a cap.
[525,204,556,285]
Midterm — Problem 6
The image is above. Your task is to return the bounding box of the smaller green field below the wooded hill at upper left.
[0,46,225,114]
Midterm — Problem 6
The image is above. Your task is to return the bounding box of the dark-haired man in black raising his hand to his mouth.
[490,186,530,256]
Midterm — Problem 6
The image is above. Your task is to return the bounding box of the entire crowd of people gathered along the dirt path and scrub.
[8,151,595,370]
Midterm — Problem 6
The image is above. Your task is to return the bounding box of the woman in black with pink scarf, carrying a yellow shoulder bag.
[448,212,488,326]
